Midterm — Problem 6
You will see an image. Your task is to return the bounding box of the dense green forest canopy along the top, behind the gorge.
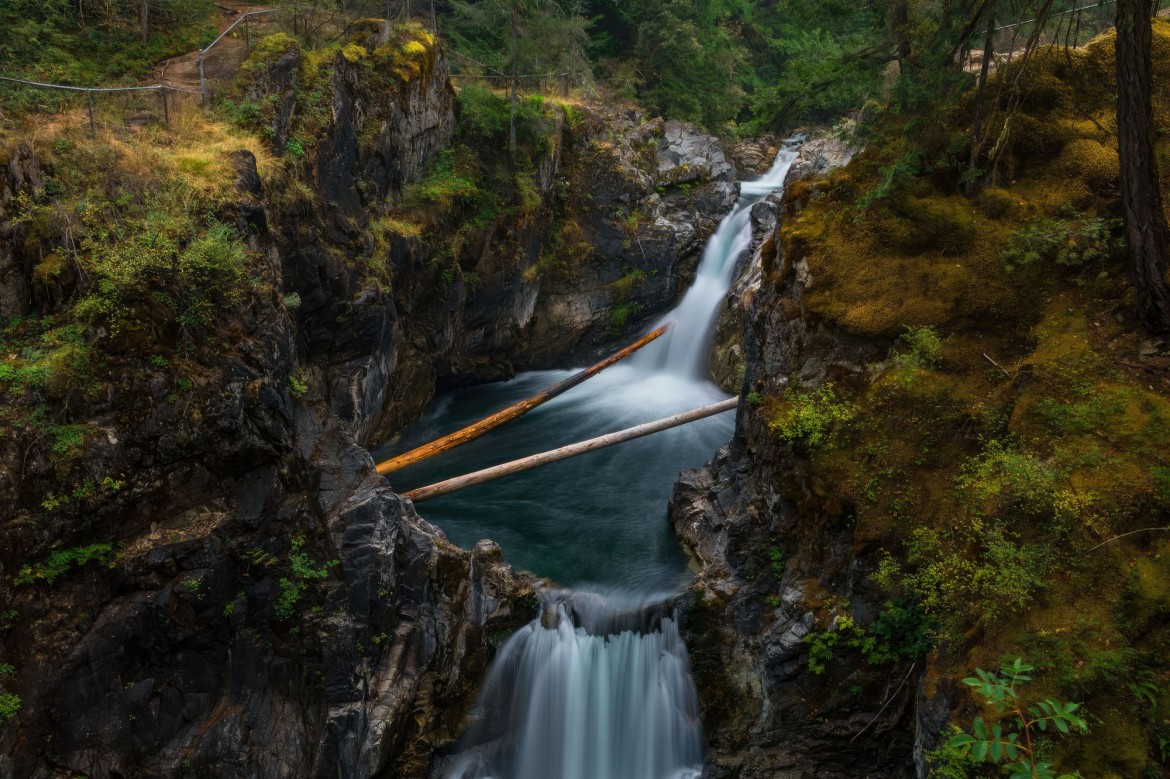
[0,0,1113,135]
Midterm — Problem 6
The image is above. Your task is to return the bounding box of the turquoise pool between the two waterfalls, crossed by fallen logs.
[374,364,735,592]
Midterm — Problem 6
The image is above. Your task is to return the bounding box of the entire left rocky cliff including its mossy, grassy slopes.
[0,24,736,779]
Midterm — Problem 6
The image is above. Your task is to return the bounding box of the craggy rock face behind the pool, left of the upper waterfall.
[249,40,737,443]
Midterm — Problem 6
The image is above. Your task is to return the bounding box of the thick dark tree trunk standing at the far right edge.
[1116,0,1170,332]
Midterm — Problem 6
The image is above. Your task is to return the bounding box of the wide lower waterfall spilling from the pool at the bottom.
[440,589,703,779]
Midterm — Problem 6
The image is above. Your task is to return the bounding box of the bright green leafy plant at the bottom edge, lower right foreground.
[948,657,1088,779]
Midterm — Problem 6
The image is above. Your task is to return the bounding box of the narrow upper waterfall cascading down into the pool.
[634,150,797,378]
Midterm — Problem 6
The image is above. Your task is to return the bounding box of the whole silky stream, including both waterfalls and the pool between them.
[374,150,796,779]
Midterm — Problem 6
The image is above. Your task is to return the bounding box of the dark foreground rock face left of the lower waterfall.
[0,143,536,779]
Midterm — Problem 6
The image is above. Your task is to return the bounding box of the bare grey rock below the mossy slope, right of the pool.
[670,156,949,779]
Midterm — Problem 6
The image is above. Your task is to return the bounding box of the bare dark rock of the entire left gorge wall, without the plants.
[0,28,737,779]
